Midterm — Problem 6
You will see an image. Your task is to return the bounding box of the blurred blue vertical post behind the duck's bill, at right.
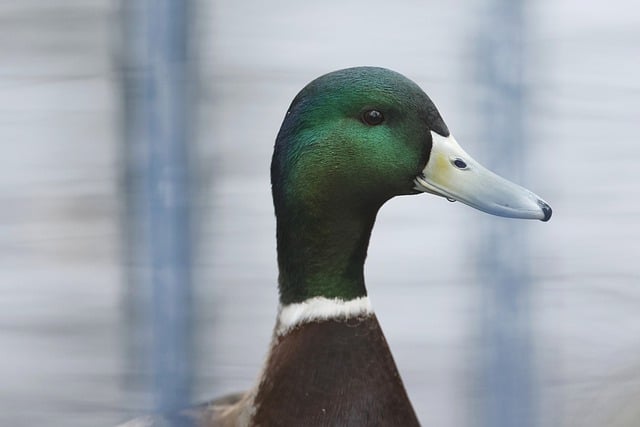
[478,0,537,427]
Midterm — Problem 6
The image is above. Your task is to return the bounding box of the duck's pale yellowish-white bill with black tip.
[415,132,551,221]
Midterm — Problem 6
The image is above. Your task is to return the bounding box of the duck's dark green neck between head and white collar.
[277,206,377,305]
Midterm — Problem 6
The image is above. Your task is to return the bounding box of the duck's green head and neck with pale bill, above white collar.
[271,67,551,306]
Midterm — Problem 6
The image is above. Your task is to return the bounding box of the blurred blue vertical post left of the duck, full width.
[122,0,192,418]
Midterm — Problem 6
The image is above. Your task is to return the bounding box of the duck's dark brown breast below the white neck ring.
[248,315,419,427]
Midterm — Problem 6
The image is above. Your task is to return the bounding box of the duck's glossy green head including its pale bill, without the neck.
[271,67,551,221]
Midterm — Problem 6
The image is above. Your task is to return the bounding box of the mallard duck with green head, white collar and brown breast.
[120,67,551,427]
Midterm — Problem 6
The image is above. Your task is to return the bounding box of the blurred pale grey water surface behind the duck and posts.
[0,0,640,426]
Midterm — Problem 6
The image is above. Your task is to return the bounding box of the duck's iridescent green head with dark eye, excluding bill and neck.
[271,67,449,215]
